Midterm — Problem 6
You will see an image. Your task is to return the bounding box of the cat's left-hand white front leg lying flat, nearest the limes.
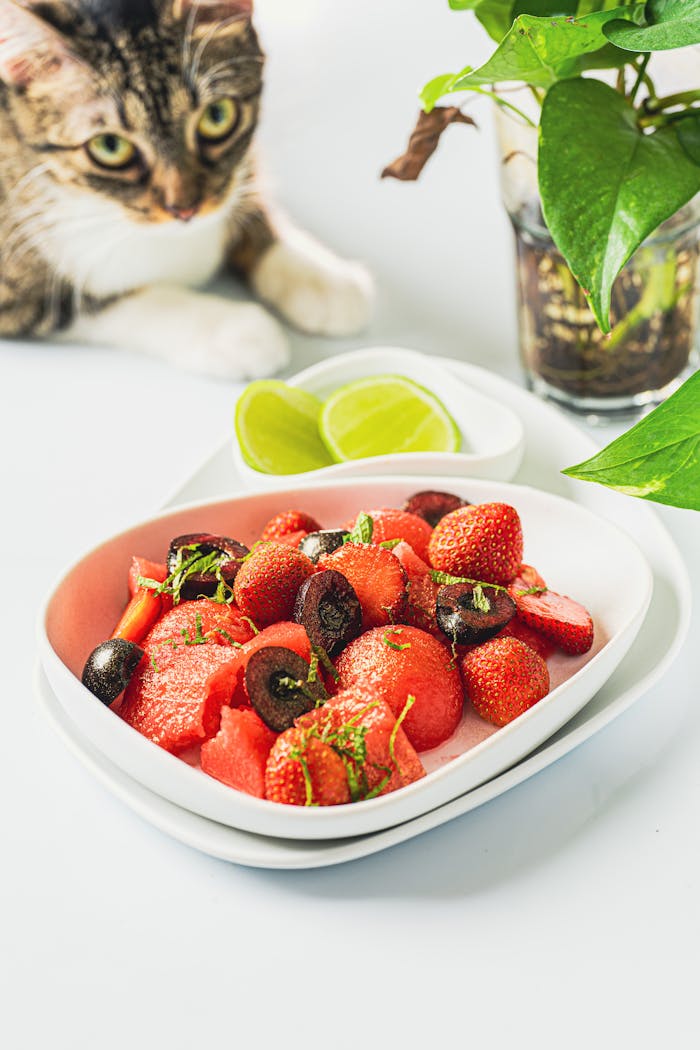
[63,287,290,381]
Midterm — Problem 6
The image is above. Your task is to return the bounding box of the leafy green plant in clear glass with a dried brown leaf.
[384,0,700,418]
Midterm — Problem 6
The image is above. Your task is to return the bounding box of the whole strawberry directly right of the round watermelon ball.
[462,637,549,726]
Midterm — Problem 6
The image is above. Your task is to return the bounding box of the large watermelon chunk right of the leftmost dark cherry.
[119,646,238,754]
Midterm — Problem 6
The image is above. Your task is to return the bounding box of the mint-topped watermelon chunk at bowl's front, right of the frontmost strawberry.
[297,690,425,798]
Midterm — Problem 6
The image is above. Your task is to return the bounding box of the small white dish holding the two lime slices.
[233,347,523,490]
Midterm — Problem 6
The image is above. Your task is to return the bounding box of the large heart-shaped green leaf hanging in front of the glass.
[538,78,700,332]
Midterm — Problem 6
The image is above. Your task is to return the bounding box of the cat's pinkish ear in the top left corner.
[0,0,79,87]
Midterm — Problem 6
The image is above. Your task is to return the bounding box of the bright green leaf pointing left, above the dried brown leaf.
[451,3,644,90]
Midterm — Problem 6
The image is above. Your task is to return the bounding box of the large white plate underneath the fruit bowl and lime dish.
[36,362,690,867]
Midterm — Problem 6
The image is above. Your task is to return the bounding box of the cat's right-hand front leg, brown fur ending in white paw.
[229,208,374,336]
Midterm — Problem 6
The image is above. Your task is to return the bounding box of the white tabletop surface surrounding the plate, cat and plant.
[0,0,700,1050]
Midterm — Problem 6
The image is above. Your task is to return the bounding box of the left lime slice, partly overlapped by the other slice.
[235,379,333,474]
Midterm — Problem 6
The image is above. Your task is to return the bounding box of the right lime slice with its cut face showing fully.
[318,376,462,461]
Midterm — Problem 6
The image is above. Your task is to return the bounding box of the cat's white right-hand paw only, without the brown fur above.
[252,230,374,336]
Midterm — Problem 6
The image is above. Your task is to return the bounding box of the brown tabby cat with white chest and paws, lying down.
[0,0,372,379]
